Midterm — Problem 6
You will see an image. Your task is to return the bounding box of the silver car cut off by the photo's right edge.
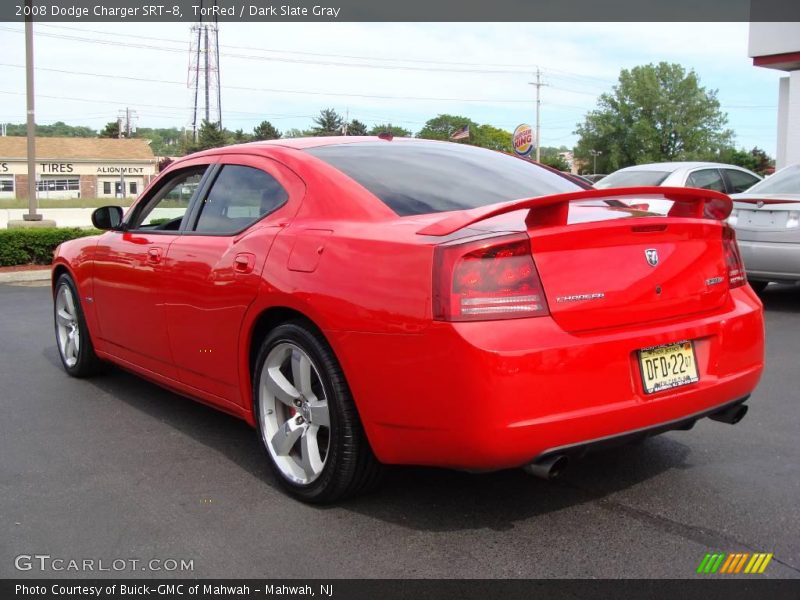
[728,164,800,291]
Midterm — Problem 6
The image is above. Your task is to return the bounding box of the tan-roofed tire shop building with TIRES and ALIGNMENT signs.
[0,136,157,200]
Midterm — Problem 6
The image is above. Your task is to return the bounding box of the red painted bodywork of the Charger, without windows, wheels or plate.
[53,138,764,470]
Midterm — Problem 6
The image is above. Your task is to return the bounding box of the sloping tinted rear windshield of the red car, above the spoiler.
[307,141,582,216]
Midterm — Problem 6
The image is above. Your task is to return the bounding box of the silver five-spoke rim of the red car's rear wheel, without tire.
[259,342,331,485]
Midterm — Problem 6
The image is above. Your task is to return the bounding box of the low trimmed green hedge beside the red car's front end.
[0,227,100,267]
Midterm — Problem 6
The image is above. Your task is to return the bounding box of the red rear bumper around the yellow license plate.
[326,286,764,469]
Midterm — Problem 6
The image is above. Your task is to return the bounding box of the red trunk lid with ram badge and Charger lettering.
[529,217,728,332]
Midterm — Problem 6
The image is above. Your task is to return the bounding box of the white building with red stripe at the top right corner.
[748,22,800,169]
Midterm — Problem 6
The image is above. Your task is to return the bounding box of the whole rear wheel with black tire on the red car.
[253,320,382,504]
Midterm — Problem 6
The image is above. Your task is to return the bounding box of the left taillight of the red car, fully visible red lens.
[433,234,550,321]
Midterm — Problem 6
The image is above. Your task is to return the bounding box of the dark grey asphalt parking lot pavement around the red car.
[0,286,800,578]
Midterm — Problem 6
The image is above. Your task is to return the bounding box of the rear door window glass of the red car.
[195,165,289,234]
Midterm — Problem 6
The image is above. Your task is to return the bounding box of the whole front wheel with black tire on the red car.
[53,273,103,377]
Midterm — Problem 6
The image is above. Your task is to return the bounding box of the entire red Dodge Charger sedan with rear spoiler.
[53,136,764,502]
